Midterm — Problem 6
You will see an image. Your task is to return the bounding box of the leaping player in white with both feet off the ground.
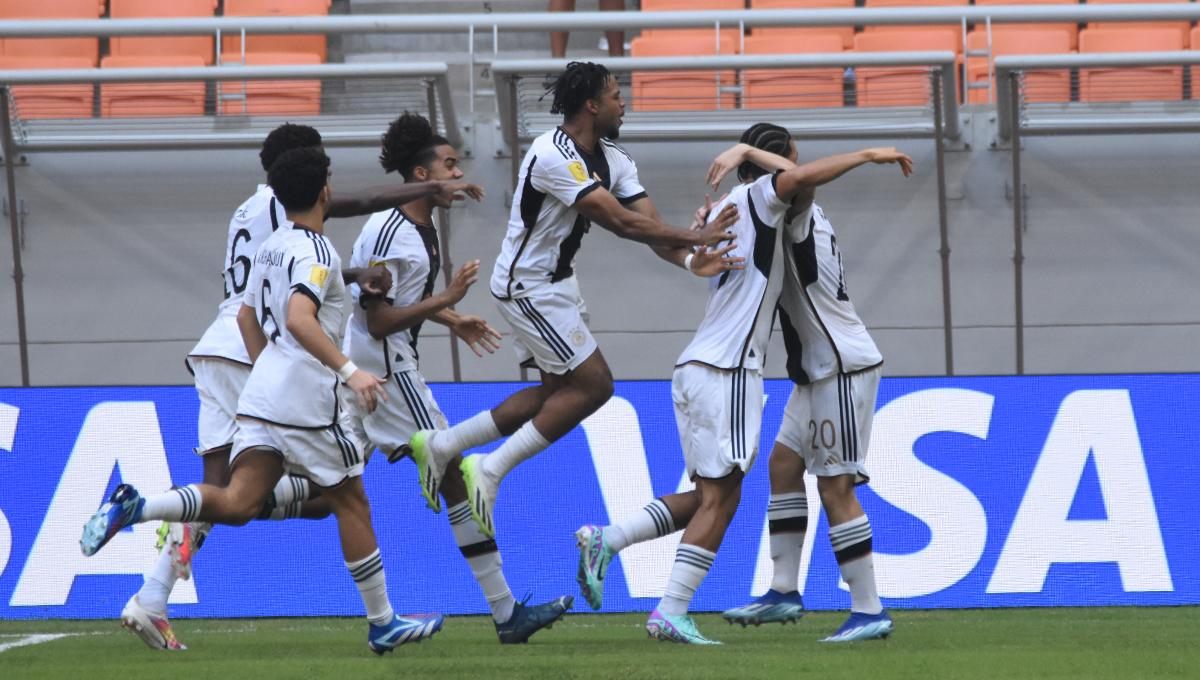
[412,61,733,537]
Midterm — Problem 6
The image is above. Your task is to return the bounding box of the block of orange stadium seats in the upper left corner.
[0,0,330,119]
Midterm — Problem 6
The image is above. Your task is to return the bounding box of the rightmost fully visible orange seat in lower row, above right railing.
[1079,28,1183,102]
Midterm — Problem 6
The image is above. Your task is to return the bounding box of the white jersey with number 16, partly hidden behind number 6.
[187,185,292,366]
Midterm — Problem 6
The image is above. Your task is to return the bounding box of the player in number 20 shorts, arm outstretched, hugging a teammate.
[714,128,912,642]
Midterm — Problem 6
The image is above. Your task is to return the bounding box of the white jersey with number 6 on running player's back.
[238,224,346,428]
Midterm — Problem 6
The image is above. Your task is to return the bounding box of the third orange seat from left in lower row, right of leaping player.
[854,29,960,107]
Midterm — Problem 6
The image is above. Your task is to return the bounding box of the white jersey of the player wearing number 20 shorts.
[779,204,883,385]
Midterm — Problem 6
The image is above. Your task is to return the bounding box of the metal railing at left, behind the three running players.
[0,62,462,386]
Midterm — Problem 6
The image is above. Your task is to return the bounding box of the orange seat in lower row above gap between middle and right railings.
[967,24,1072,104]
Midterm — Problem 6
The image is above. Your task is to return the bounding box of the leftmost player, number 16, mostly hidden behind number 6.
[121,124,480,650]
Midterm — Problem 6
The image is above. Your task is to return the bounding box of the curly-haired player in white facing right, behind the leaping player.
[346,112,572,644]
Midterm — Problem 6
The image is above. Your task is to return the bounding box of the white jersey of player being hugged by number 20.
[676,175,788,371]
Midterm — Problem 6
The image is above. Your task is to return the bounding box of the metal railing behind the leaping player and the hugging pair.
[491,52,961,375]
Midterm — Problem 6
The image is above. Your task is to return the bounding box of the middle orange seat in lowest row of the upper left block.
[100,54,204,118]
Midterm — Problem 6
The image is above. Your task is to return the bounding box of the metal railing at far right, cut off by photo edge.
[996,52,1200,375]
